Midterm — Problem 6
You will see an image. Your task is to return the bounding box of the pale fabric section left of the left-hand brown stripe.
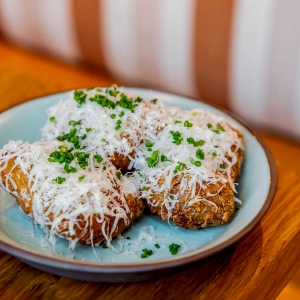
[0,0,79,60]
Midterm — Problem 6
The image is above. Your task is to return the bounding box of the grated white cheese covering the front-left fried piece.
[0,141,137,246]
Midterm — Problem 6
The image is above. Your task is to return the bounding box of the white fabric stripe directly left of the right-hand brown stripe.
[154,0,197,97]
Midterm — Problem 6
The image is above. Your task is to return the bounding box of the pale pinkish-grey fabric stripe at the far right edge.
[266,0,300,137]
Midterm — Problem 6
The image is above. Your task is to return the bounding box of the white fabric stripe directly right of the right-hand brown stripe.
[230,0,275,124]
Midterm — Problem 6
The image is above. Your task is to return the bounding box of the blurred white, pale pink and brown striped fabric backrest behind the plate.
[0,0,300,139]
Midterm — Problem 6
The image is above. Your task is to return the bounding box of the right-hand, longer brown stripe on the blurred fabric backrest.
[194,0,235,106]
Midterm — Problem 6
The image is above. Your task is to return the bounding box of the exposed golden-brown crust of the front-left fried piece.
[1,158,144,244]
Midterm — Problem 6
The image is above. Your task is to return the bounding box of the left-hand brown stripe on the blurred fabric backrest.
[73,0,104,67]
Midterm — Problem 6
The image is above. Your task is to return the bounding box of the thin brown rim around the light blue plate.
[0,86,278,274]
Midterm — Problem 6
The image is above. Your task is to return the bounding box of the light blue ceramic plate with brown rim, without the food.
[0,88,277,282]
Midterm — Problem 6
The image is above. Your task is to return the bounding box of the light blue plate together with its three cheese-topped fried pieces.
[0,86,277,282]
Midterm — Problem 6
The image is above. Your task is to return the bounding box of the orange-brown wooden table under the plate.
[0,39,300,299]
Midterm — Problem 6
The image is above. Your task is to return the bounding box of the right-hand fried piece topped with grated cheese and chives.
[137,109,243,229]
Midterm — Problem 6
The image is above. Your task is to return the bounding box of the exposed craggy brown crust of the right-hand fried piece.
[145,149,243,229]
